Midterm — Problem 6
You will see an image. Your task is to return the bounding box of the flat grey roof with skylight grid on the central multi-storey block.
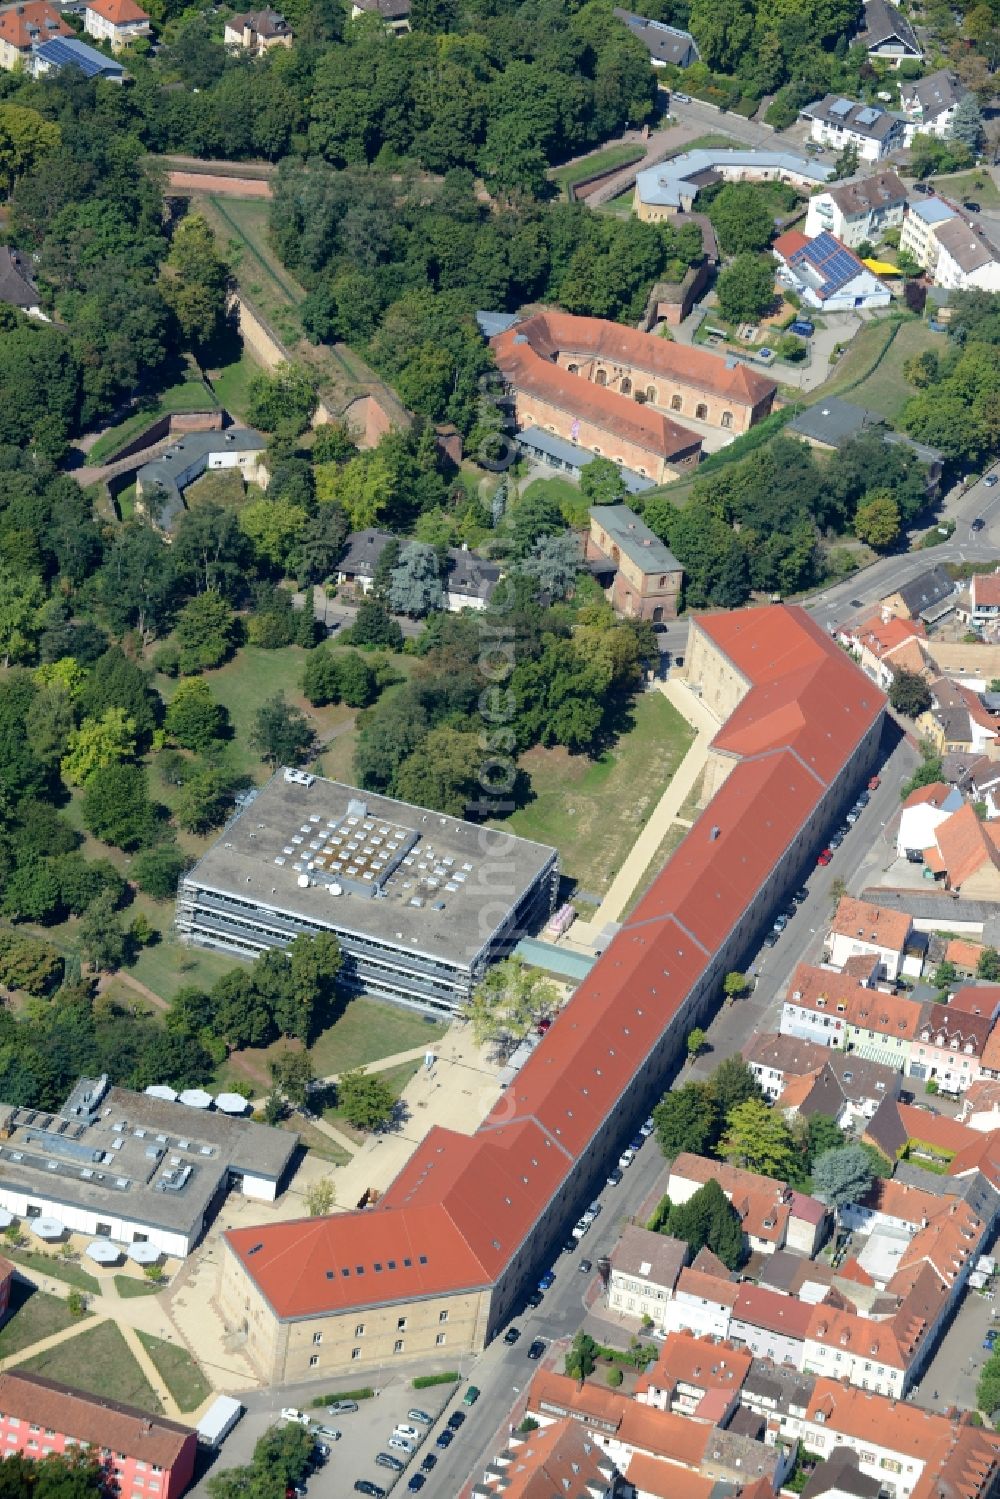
[183,769,556,968]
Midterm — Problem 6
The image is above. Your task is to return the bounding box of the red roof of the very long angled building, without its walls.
[226,602,885,1318]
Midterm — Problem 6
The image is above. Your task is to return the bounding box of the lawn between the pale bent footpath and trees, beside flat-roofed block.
[504,693,694,895]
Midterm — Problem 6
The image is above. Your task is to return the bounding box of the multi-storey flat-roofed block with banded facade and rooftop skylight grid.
[177,769,559,1013]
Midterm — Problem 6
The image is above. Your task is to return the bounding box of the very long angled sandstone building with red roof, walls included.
[220,606,885,1382]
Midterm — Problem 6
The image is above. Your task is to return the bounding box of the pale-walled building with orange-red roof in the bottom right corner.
[801,1379,1000,1499]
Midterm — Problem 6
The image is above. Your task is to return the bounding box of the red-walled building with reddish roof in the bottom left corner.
[0,1369,198,1499]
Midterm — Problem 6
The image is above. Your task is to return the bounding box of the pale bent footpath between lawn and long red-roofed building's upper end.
[567,676,718,947]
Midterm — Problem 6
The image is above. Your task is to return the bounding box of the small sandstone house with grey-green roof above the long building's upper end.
[585,505,684,624]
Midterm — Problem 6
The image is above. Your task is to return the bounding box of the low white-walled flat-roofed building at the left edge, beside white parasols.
[0,1078,295,1259]
